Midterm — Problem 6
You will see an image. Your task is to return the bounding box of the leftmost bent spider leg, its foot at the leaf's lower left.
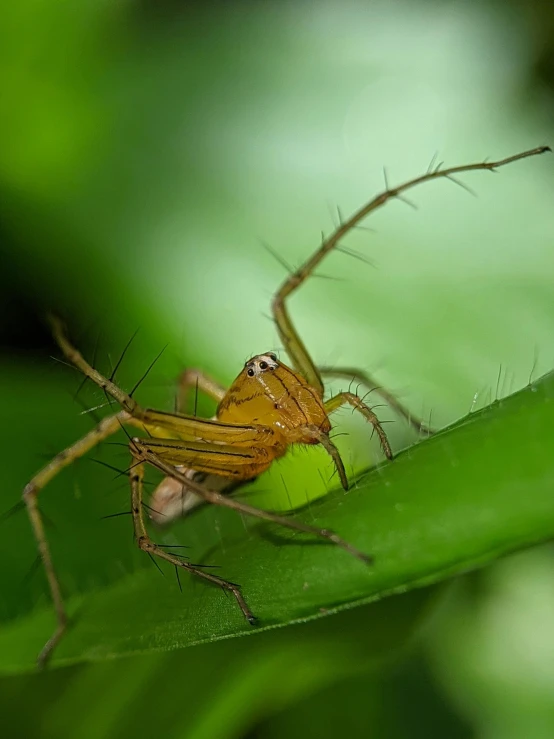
[23,411,146,667]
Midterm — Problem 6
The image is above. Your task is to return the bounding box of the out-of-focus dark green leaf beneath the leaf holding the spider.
[0,588,436,739]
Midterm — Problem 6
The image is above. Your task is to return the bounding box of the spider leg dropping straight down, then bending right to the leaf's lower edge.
[131,456,256,624]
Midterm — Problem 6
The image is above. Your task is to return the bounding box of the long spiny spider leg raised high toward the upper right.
[271,146,550,397]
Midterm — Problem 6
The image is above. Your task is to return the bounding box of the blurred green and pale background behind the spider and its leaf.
[0,0,554,739]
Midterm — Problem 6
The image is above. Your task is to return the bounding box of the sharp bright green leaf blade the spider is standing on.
[0,373,554,671]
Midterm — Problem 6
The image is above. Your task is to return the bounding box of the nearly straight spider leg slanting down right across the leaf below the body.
[131,439,372,563]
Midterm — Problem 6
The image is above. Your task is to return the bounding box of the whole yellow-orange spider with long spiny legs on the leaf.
[23,146,550,665]
